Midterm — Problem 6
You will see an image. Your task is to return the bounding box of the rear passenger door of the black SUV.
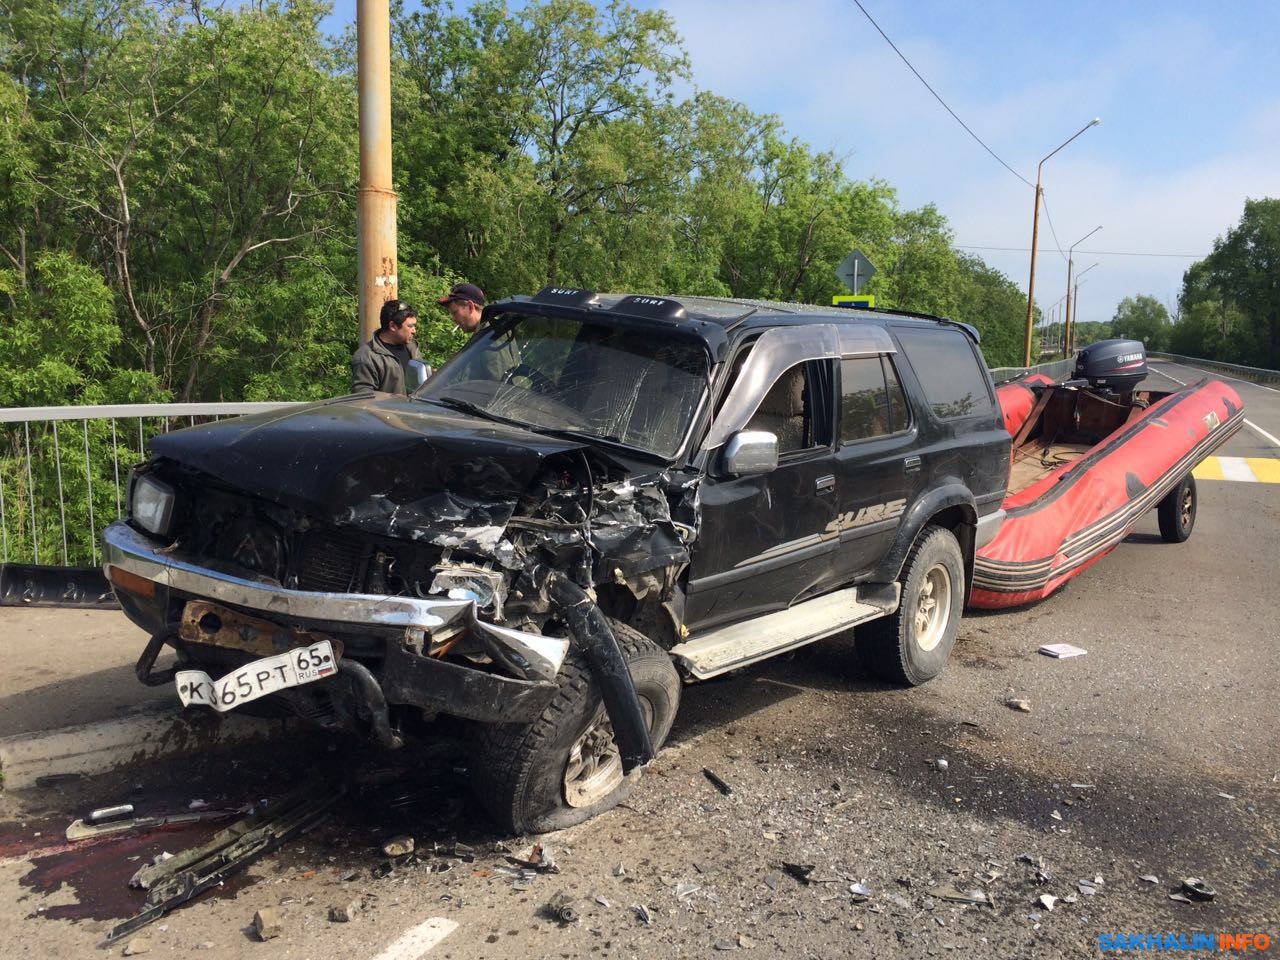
[832,353,923,582]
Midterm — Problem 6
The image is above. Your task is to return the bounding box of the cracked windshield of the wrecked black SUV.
[416,315,707,458]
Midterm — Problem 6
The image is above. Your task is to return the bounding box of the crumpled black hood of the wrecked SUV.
[151,397,586,545]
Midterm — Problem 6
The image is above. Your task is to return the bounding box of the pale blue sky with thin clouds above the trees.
[320,0,1280,321]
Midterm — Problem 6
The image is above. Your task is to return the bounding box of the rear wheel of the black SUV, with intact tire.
[854,526,965,686]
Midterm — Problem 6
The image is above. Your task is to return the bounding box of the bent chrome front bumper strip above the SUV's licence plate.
[102,521,568,681]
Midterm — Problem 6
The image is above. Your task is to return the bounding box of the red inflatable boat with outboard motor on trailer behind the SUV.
[969,340,1244,608]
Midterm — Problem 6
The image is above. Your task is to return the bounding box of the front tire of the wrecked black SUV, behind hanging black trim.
[470,620,680,833]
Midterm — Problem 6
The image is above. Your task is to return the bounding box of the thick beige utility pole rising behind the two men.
[356,0,399,342]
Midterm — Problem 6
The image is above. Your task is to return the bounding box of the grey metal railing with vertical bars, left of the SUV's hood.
[0,403,292,583]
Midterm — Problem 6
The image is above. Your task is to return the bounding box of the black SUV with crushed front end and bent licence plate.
[105,288,1010,831]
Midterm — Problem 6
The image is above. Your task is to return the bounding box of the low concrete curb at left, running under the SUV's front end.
[0,708,292,790]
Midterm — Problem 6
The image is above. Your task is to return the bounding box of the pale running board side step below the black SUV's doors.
[671,584,902,680]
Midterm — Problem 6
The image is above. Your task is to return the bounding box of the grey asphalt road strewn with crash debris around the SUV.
[0,362,1280,960]
